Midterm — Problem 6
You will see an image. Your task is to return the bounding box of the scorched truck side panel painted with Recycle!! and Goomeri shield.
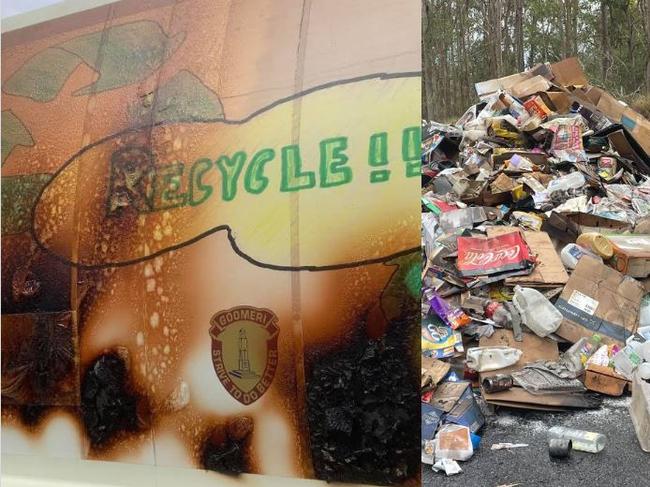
[2,0,421,484]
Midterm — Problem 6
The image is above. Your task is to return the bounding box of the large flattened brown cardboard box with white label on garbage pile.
[555,256,645,345]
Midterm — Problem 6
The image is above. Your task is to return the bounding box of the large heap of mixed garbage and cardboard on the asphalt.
[421,58,650,475]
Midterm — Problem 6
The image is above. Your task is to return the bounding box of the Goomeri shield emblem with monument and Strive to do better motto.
[210,306,280,405]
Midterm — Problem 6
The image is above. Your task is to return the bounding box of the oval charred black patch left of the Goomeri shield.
[81,352,138,447]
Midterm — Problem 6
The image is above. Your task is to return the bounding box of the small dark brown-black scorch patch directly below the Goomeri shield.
[200,416,254,475]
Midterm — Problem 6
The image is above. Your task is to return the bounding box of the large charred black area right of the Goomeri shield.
[307,313,420,485]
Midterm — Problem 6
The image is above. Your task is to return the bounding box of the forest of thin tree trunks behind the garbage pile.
[422,0,650,122]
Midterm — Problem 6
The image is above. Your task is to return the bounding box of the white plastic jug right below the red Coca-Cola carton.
[512,286,562,337]
